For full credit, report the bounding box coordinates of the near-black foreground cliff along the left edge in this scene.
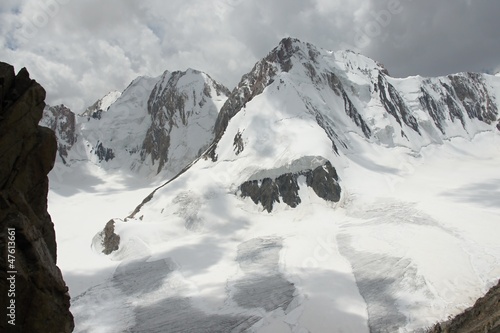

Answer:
[0,63,74,332]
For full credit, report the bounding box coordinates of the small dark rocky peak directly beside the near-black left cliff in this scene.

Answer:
[40,105,77,164]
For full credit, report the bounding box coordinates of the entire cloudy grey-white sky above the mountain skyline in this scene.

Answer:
[0,0,500,113]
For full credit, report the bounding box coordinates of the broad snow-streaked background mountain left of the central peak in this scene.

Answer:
[74,69,229,178]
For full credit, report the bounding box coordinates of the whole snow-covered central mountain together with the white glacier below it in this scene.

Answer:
[49,39,500,332]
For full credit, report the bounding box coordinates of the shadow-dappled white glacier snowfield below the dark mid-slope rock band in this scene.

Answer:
[59,133,500,332]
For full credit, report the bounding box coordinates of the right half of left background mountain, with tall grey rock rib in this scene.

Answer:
[141,70,229,172]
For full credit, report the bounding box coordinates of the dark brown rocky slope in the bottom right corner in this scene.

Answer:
[428,281,500,333]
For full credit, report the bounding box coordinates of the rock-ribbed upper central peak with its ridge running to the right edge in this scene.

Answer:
[208,38,498,159]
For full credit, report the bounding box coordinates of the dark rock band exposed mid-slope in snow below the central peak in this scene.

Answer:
[240,161,341,213]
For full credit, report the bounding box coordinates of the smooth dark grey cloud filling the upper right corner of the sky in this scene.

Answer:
[366,0,500,76]
